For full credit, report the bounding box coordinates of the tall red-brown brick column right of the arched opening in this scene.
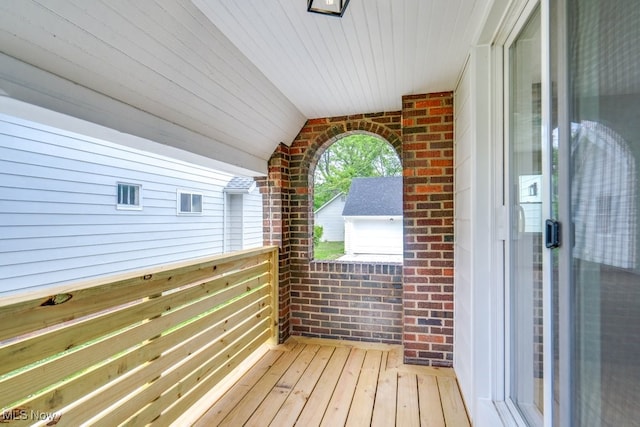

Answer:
[402,92,453,366]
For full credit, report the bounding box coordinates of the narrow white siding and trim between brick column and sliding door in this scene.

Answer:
[453,46,504,426]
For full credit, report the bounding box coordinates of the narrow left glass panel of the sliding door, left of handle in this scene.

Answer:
[508,4,548,425]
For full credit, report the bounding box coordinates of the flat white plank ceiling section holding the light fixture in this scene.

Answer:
[193,0,488,118]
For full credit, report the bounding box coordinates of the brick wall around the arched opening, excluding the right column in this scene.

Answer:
[290,112,402,343]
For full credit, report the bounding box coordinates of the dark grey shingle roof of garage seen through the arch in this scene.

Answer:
[342,176,402,216]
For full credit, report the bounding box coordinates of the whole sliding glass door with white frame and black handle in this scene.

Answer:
[504,0,640,427]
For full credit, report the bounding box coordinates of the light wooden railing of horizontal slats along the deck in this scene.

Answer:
[0,247,278,426]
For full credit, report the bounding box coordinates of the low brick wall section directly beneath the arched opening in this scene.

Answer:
[291,261,402,344]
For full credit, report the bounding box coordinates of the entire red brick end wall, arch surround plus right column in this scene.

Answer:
[260,93,453,366]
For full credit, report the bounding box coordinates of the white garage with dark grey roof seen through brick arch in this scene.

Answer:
[342,176,403,255]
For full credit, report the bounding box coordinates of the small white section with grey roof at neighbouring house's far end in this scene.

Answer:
[224,177,262,252]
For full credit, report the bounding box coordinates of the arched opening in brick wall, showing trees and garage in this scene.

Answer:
[313,132,403,262]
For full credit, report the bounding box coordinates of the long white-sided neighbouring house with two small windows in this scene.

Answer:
[0,114,262,294]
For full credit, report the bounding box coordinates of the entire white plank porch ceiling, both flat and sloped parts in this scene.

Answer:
[0,0,491,172]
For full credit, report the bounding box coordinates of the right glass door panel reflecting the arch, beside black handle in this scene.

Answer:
[560,0,640,427]
